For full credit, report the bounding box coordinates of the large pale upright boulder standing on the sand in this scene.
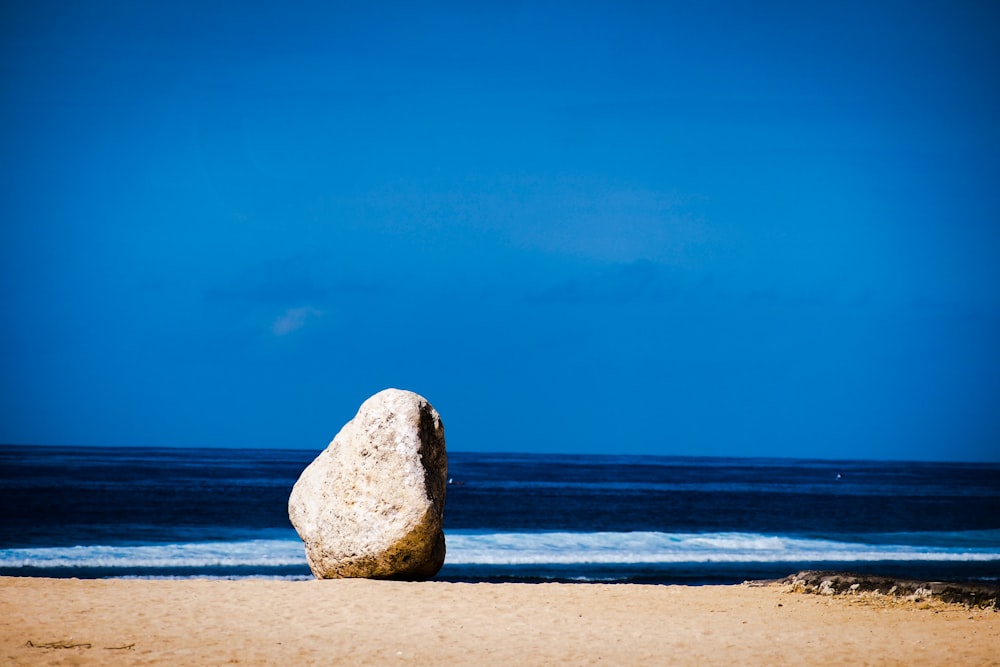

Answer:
[288,389,448,579]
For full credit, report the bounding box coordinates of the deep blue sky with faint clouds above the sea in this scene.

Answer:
[0,1,1000,461]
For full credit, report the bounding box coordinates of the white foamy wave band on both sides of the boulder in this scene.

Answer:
[0,531,1000,570]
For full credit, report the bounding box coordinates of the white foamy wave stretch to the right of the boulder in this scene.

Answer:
[447,532,1000,565]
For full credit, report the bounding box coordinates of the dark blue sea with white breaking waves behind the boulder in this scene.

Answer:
[0,446,1000,584]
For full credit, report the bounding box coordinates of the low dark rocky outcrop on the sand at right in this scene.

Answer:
[754,570,1000,610]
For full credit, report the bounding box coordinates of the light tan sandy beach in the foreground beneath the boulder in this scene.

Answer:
[0,578,1000,667]
